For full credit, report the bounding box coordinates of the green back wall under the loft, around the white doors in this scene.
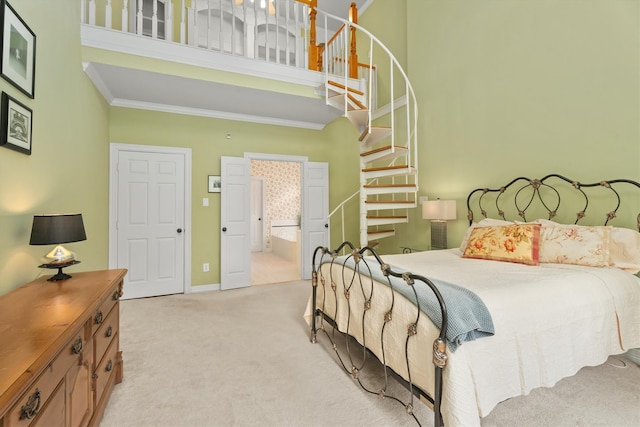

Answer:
[109,108,358,286]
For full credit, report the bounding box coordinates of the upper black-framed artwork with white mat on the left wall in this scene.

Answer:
[0,0,36,98]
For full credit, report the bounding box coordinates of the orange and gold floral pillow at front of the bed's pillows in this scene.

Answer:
[462,224,541,265]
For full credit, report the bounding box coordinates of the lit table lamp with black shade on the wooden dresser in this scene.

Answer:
[29,214,87,281]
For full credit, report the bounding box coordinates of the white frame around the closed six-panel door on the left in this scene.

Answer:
[109,142,191,293]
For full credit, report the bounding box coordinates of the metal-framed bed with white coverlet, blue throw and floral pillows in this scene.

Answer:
[306,174,640,426]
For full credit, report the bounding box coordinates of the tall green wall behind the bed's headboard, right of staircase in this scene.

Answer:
[396,0,640,251]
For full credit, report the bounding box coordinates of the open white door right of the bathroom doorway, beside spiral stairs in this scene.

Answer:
[301,162,329,280]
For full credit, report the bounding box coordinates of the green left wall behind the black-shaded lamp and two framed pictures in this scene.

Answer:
[0,0,109,294]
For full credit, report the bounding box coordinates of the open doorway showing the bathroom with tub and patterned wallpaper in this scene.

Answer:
[251,159,302,285]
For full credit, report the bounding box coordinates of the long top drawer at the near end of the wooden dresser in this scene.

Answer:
[3,330,86,427]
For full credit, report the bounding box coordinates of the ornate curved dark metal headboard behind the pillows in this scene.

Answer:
[467,174,640,230]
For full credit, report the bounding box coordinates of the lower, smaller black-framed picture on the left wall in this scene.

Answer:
[0,92,33,155]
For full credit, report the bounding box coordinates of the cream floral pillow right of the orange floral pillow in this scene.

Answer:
[538,220,612,267]
